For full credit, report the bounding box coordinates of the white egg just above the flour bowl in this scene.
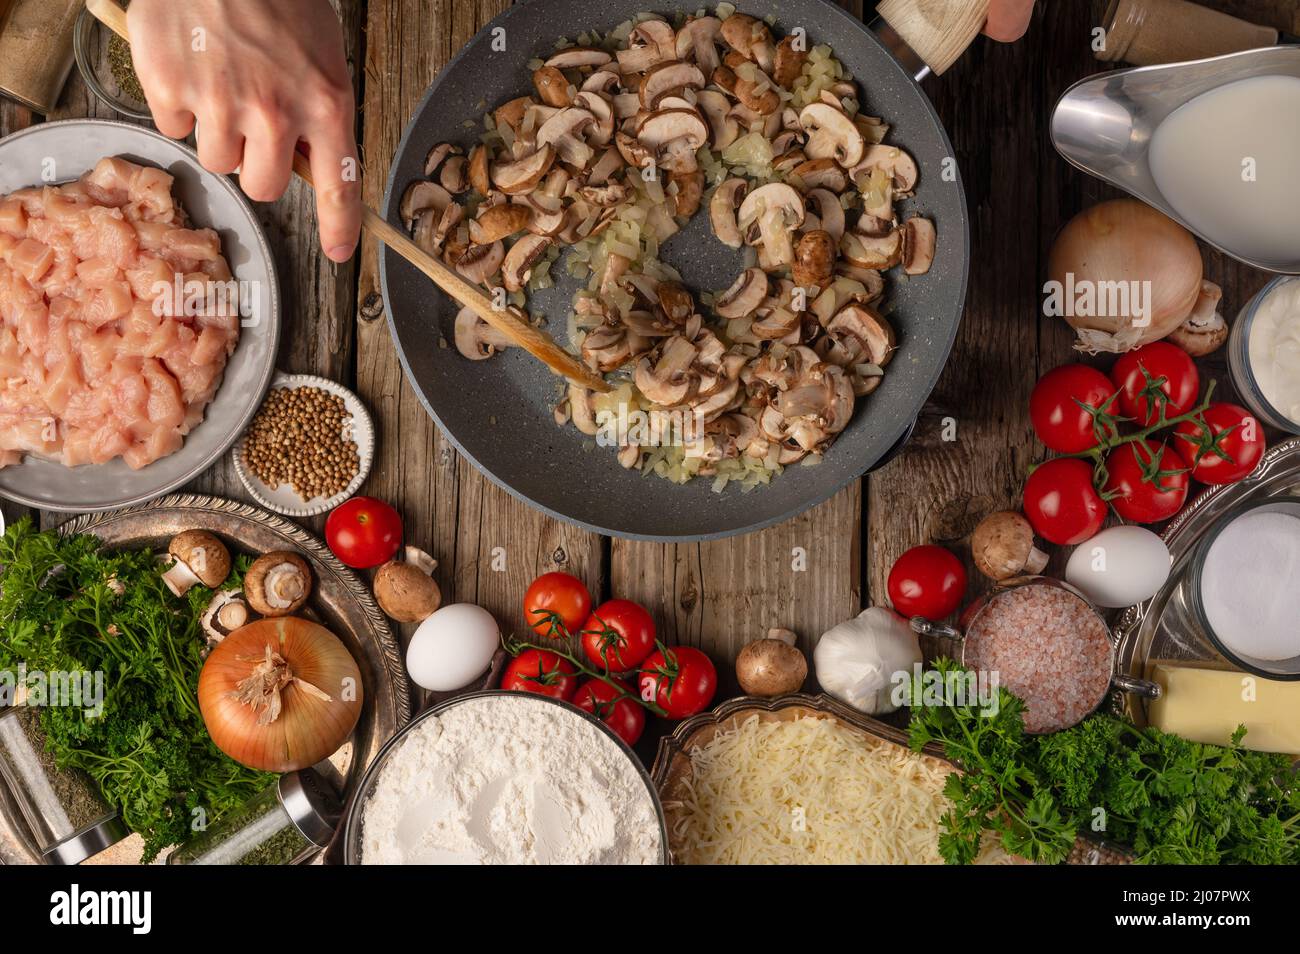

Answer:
[407,603,501,693]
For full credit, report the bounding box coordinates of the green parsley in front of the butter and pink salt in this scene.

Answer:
[909,659,1300,864]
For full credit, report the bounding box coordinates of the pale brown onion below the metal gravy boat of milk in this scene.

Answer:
[1044,199,1213,352]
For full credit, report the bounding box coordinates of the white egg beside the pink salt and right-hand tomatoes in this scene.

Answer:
[1065,526,1170,610]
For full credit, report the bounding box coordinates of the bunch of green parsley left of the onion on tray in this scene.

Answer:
[0,520,272,860]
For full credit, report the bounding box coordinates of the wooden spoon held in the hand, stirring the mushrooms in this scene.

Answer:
[86,0,610,393]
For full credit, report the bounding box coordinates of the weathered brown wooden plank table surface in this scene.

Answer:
[0,0,1295,738]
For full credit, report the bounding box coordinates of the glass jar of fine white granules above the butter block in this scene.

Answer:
[1187,496,1300,680]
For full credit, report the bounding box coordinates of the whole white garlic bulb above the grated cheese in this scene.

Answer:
[813,606,920,715]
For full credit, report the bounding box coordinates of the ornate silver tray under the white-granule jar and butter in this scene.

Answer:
[1114,438,1300,725]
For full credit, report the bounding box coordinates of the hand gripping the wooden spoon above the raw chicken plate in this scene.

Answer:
[127,0,361,261]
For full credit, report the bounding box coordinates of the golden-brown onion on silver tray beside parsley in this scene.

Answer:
[199,616,361,772]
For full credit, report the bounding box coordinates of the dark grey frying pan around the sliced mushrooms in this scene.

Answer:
[380,0,985,541]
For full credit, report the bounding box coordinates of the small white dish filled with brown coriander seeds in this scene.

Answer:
[235,373,374,517]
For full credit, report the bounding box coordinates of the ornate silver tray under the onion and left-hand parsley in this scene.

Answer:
[0,494,411,864]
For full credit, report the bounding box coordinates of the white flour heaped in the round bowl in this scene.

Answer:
[361,695,662,864]
